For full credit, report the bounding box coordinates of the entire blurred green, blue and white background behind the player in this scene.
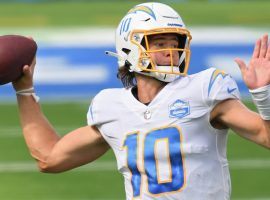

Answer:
[0,0,270,200]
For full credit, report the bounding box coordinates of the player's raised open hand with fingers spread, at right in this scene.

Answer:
[235,34,270,89]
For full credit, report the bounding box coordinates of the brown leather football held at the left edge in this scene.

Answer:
[0,35,37,85]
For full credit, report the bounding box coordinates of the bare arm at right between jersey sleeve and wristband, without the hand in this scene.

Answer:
[210,99,270,148]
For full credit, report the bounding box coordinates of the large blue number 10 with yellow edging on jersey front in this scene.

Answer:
[123,127,185,197]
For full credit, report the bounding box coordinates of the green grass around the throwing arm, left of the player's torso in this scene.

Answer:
[0,103,124,200]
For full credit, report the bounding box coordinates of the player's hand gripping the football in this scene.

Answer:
[12,58,36,91]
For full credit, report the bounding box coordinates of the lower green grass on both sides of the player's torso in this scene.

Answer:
[0,102,270,200]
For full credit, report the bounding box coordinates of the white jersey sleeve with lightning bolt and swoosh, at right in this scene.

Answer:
[203,68,240,107]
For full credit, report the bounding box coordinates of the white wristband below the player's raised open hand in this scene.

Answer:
[249,85,270,120]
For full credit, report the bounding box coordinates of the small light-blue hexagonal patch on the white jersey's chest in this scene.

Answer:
[169,99,190,118]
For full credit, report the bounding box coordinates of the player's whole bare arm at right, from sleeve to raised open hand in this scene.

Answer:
[211,34,270,148]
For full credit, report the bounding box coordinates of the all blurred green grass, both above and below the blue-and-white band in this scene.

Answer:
[0,0,270,200]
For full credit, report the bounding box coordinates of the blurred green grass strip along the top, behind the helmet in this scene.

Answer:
[0,0,270,28]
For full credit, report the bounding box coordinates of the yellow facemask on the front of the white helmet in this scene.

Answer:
[130,28,191,82]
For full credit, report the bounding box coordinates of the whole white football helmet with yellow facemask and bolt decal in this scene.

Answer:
[107,3,191,82]
